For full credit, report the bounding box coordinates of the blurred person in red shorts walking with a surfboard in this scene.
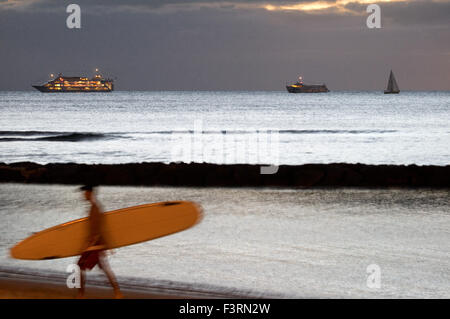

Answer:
[78,185,123,298]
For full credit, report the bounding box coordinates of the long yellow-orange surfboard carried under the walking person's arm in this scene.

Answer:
[10,201,202,260]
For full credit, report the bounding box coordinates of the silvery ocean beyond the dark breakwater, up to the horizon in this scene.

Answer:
[0,92,450,165]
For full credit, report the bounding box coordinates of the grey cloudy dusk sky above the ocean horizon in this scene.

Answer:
[0,0,450,91]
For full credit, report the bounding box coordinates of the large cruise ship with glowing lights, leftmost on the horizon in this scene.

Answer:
[32,69,114,93]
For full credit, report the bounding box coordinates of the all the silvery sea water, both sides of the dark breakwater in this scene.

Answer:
[0,92,450,298]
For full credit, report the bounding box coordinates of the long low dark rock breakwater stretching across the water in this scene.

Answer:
[0,162,450,189]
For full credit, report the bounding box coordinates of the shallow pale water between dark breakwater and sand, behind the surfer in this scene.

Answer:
[0,183,450,298]
